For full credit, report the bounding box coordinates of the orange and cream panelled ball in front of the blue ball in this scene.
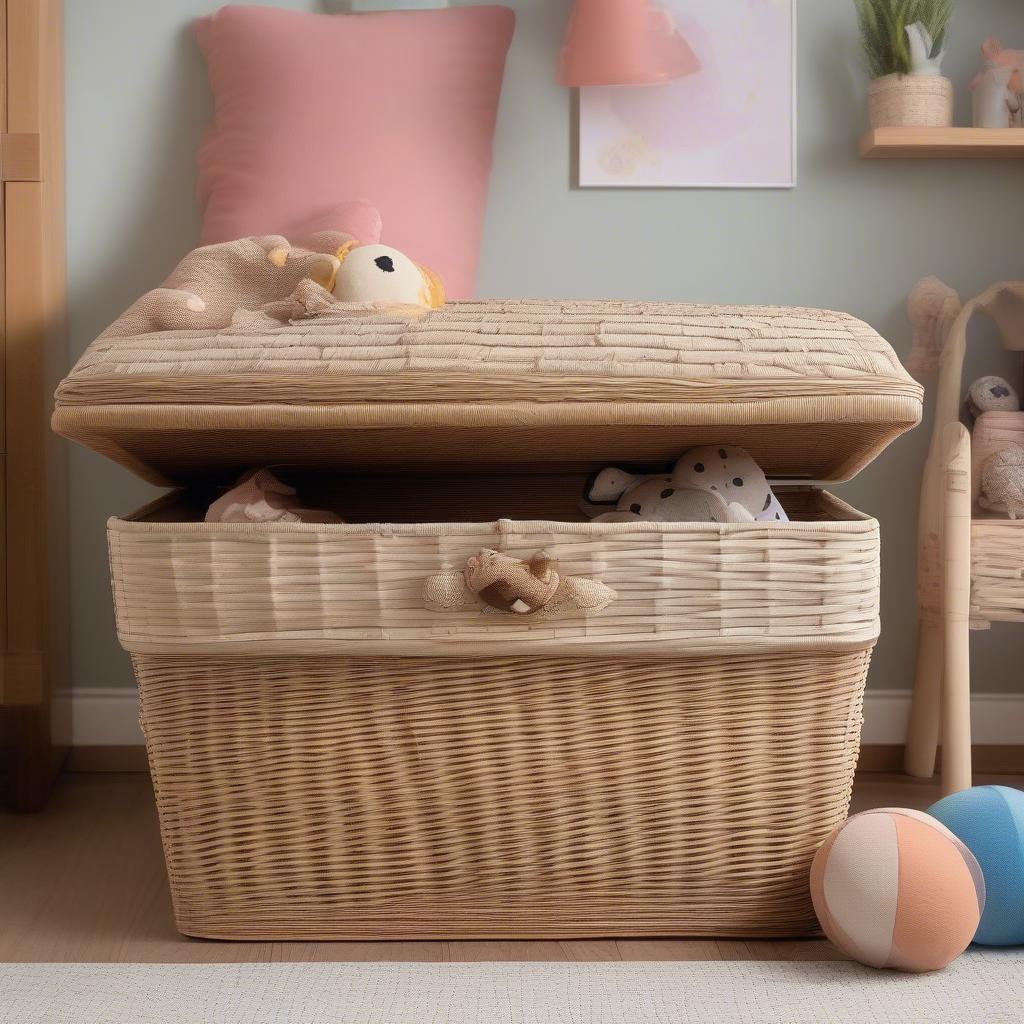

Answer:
[811,808,985,972]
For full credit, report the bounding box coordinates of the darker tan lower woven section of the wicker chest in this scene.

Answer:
[134,650,868,939]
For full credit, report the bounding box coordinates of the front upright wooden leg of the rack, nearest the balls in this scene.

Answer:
[941,423,971,796]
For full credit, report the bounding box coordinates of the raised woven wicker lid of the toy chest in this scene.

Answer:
[53,300,922,483]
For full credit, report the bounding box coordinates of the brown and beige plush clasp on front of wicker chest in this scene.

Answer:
[423,549,616,620]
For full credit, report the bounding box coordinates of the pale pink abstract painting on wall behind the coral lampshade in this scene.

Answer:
[580,0,797,188]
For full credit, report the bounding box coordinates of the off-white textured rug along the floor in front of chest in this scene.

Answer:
[0,951,1024,1024]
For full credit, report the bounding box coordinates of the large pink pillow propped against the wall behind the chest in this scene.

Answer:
[196,6,515,298]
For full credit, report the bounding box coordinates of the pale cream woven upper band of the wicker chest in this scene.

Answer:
[109,496,879,657]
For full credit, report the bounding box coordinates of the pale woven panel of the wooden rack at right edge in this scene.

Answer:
[971,519,1024,629]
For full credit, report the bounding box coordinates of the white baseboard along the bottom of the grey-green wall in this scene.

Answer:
[66,687,1024,746]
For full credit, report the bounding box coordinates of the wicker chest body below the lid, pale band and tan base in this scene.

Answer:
[110,490,879,939]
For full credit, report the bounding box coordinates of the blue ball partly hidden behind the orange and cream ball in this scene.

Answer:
[928,785,1024,946]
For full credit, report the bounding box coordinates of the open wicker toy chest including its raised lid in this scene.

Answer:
[54,301,922,939]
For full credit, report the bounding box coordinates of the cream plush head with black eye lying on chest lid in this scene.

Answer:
[312,243,444,309]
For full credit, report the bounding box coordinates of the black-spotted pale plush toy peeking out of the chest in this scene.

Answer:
[587,444,790,522]
